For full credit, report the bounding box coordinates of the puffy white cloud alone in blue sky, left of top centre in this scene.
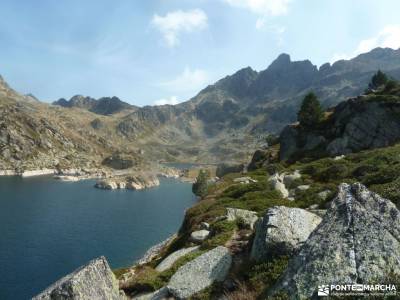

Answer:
[151,9,208,48]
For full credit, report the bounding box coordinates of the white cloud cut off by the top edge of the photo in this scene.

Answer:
[223,0,291,16]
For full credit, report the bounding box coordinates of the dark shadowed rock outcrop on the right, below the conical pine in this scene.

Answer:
[280,82,400,160]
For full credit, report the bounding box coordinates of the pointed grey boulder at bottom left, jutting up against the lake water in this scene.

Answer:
[33,257,122,300]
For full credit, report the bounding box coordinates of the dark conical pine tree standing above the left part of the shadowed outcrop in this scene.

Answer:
[297,92,323,128]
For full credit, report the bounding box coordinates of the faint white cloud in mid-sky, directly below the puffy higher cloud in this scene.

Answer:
[159,67,210,92]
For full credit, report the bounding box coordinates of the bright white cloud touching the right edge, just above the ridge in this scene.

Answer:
[331,25,400,62]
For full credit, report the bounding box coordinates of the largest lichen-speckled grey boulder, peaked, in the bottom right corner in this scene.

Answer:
[271,183,400,299]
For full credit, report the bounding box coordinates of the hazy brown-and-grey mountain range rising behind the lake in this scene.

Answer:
[0,48,400,169]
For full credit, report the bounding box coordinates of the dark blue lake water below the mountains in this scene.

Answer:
[0,177,195,300]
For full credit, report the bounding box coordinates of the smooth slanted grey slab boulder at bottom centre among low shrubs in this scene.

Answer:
[168,246,232,299]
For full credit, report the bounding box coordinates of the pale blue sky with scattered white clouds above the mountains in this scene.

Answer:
[0,0,400,106]
